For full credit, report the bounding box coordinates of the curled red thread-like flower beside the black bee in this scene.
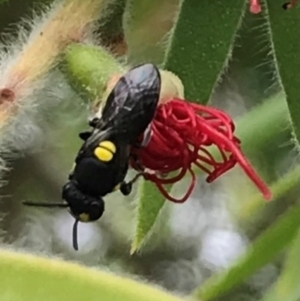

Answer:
[131,99,271,203]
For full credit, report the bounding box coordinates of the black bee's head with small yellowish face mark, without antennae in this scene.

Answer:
[62,181,104,222]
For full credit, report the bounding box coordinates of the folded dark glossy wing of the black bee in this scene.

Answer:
[97,64,161,141]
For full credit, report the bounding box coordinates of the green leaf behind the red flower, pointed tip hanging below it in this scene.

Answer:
[131,0,246,252]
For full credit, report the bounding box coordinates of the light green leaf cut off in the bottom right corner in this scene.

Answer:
[261,229,300,301]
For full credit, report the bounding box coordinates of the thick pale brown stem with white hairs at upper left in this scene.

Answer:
[0,0,106,152]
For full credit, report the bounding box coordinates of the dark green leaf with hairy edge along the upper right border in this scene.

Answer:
[264,0,300,151]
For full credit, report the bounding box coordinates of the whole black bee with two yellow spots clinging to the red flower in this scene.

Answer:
[23,64,161,250]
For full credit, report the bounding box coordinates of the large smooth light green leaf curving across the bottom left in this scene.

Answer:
[0,250,185,301]
